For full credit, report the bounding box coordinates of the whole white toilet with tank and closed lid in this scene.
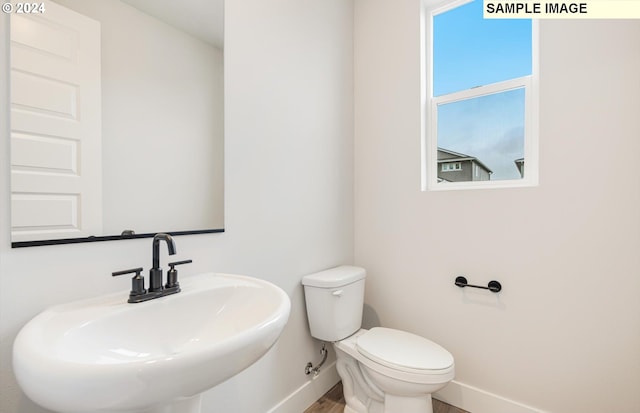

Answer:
[302,266,454,413]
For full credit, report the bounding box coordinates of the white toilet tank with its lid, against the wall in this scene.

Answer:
[302,265,366,342]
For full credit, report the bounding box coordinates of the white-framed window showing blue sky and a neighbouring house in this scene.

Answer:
[423,0,538,190]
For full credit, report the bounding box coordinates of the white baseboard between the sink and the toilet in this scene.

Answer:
[267,361,340,413]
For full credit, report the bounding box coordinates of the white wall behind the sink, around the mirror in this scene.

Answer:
[0,0,353,413]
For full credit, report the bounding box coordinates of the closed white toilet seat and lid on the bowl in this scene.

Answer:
[356,327,454,375]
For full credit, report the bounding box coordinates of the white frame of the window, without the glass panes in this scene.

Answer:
[420,0,539,191]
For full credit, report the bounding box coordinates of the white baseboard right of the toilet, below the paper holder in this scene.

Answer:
[433,380,546,413]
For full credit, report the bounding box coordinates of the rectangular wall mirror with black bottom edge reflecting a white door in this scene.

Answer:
[10,0,224,247]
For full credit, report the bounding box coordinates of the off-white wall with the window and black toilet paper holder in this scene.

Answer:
[354,0,640,413]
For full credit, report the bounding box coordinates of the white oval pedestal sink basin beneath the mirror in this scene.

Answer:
[13,273,291,413]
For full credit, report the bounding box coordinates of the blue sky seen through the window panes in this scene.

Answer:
[433,0,531,180]
